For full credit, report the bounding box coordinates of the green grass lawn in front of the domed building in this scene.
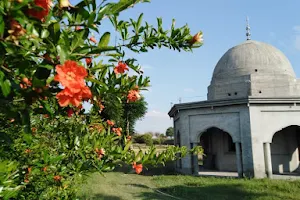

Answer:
[80,172,300,200]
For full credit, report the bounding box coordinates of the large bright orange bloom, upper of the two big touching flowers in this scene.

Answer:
[54,60,88,93]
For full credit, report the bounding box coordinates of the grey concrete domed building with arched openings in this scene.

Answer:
[169,38,300,178]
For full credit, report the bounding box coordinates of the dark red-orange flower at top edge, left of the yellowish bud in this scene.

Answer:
[28,0,52,21]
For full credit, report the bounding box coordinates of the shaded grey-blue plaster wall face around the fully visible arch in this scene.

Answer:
[174,105,253,176]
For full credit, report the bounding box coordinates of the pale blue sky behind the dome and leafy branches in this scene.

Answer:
[71,0,300,133]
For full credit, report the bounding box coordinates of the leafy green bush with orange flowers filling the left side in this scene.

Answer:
[0,0,202,199]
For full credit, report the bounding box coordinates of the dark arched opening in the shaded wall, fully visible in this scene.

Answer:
[198,127,237,172]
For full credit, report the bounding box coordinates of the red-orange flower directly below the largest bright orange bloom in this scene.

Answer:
[56,86,92,107]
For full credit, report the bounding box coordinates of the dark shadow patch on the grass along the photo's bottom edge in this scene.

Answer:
[136,183,281,200]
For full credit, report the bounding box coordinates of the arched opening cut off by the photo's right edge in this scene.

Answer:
[271,125,300,175]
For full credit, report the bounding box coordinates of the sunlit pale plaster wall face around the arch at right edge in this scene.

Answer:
[249,104,300,178]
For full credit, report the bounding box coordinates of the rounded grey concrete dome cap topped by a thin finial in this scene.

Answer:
[212,40,296,81]
